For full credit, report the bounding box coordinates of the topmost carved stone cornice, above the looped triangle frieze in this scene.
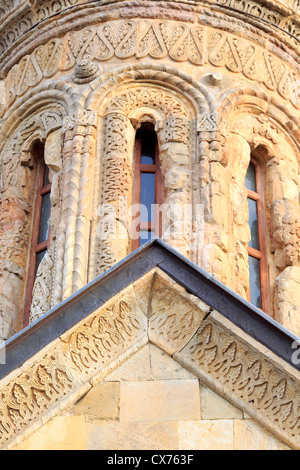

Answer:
[0,0,300,68]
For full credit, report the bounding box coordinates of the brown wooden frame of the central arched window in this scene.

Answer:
[132,124,163,251]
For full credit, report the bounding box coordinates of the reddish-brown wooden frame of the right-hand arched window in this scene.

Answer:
[247,155,270,314]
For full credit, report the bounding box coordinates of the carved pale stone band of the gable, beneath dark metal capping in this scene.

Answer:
[0,268,300,449]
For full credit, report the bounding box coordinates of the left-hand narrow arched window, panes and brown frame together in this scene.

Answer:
[23,142,51,326]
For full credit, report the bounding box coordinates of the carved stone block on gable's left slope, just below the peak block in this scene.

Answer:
[62,287,147,380]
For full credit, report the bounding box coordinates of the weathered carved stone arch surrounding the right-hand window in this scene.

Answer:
[218,88,300,316]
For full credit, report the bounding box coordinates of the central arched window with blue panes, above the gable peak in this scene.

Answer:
[132,124,163,250]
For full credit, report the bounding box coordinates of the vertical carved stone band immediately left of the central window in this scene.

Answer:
[94,113,133,275]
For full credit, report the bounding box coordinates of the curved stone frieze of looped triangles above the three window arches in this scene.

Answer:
[5,20,300,115]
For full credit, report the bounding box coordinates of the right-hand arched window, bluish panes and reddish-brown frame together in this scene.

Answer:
[246,157,269,313]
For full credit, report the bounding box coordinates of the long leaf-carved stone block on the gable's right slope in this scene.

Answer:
[183,320,300,439]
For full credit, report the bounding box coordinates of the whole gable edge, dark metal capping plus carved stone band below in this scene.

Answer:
[0,239,300,448]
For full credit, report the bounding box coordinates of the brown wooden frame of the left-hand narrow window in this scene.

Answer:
[23,143,51,328]
